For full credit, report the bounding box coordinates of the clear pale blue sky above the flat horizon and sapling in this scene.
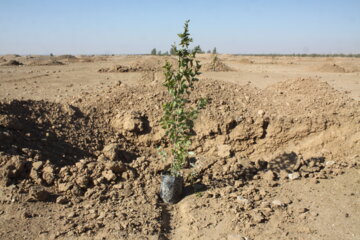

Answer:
[0,0,360,54]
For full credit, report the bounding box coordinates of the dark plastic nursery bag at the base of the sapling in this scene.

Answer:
[160,175,183,203]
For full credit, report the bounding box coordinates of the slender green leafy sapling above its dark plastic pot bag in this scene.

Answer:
[161,20,207,202]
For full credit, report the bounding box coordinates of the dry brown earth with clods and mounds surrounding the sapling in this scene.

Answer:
[0,54,360,240]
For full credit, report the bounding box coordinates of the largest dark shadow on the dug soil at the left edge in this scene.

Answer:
[0,101,91,167]
